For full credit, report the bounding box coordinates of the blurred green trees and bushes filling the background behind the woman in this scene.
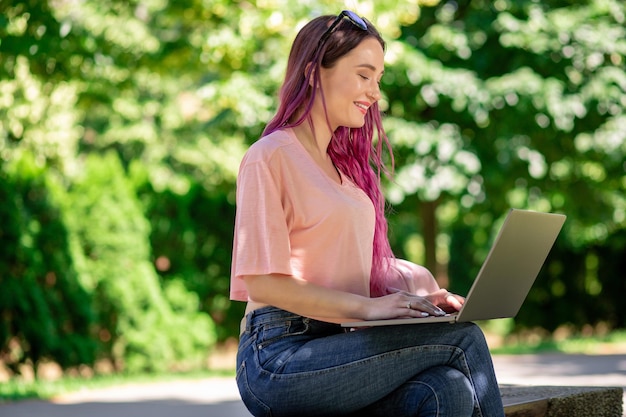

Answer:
[0,0,626,376]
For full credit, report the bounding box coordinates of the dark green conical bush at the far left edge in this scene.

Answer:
[0,153,97,373]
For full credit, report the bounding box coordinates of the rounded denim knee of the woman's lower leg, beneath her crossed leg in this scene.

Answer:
[354,366,474,417]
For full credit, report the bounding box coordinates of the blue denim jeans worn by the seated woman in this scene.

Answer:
[237,307,504,417]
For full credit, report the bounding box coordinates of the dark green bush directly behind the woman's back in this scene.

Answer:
[130,162,245,341]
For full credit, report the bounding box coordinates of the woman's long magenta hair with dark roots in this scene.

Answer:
[263,16,393,296]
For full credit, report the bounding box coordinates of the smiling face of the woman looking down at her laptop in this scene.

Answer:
[313,37,384,131]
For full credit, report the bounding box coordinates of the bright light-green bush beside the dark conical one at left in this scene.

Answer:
[58,152,215,372]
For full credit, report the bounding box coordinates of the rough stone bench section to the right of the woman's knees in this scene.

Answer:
[500,385,624,417]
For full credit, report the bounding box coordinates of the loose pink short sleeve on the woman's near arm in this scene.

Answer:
[231,154,291,301]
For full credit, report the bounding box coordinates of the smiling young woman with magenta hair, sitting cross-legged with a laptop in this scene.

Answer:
[231,11,504,417]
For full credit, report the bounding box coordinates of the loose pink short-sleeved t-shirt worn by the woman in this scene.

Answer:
[230,129,375,301]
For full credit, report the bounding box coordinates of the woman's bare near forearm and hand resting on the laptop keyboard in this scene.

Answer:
[243,275,443,320]
